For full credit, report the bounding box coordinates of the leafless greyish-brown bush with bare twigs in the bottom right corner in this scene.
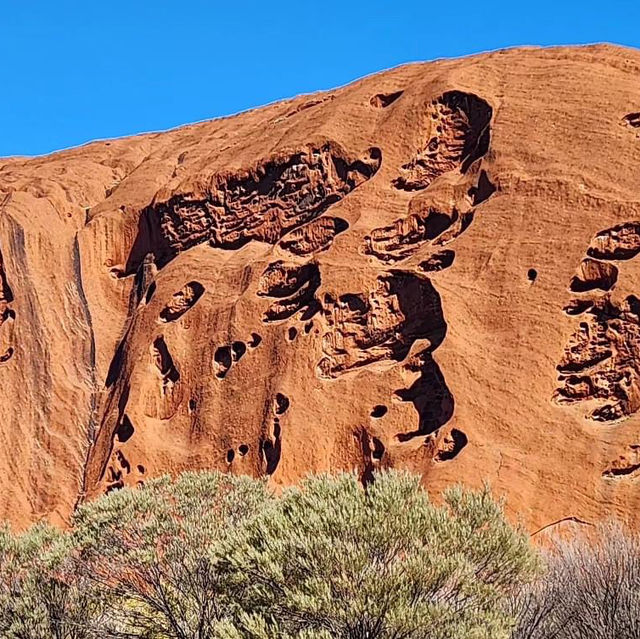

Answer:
[510,523,640,639]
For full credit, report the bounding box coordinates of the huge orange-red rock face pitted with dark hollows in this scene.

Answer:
[0,46,640,532]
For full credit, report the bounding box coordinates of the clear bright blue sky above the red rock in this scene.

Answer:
[0,0,640,156]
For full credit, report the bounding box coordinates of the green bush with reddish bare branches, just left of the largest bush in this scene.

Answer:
[72,473,268,639]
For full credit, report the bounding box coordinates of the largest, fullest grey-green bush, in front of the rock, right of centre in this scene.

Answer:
[226,472,537,639]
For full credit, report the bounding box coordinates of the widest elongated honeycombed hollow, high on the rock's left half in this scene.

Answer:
[139,141,382,272]
